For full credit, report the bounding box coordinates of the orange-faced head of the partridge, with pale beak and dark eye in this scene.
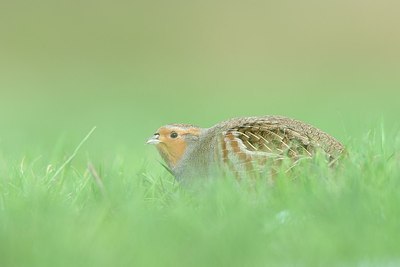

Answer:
[147,124,201,169]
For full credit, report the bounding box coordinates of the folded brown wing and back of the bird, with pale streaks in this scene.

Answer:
[218,116,343,176]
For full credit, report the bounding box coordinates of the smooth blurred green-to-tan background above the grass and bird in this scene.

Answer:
[0,0,400,157]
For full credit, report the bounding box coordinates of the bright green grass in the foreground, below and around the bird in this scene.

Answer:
[0,123,400,266]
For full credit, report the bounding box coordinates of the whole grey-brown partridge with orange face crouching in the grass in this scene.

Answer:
[147,115,345,181]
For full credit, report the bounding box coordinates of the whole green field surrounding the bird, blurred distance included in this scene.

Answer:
[0,0,400,267]
